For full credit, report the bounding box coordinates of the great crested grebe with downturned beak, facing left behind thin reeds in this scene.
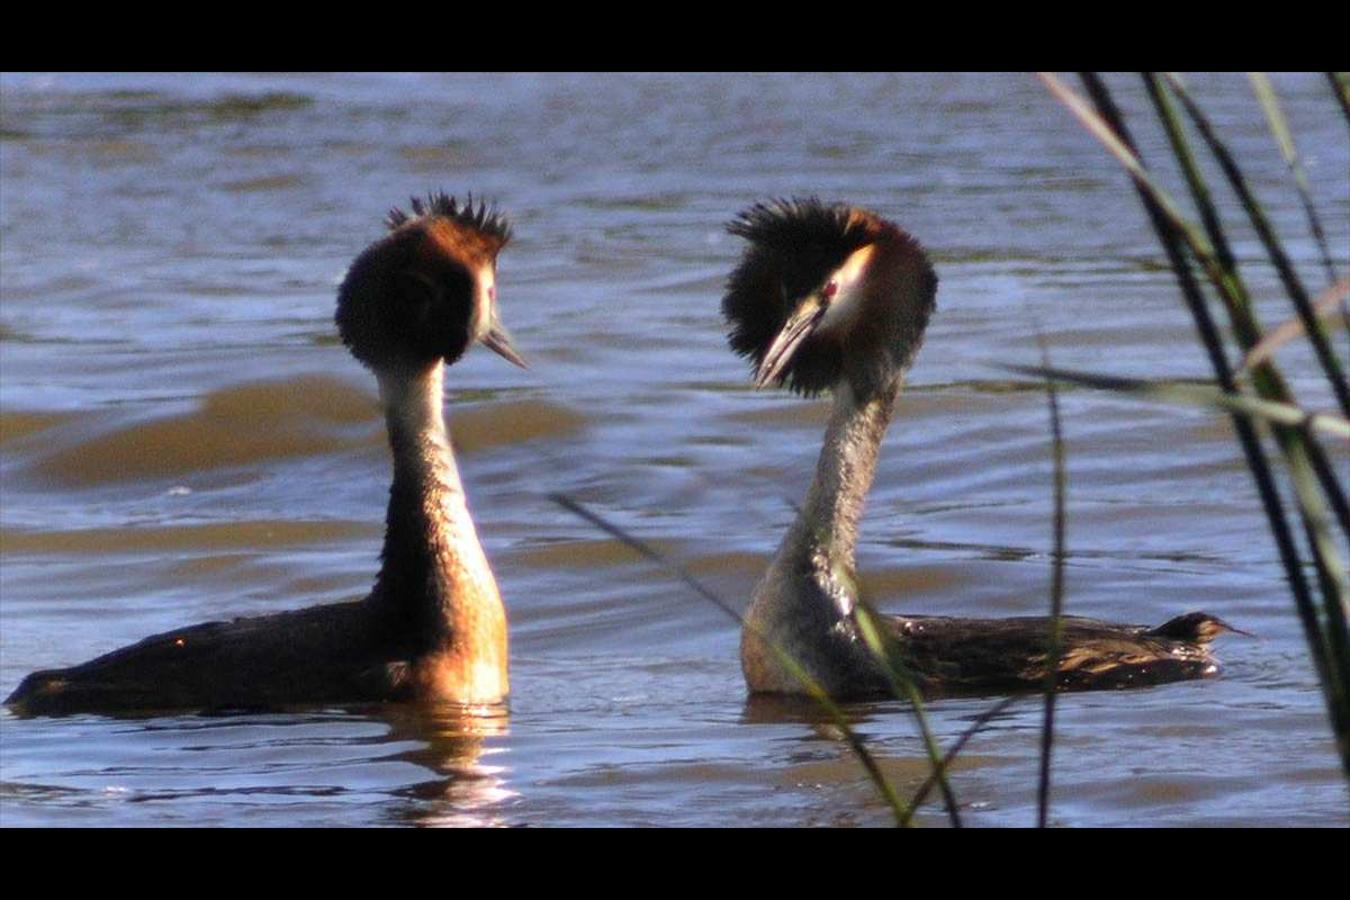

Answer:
[722,197,1237,698]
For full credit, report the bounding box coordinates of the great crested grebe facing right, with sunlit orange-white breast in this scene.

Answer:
[5,194,524,715]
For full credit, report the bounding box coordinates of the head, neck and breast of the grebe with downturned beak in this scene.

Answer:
[722,197,937,694]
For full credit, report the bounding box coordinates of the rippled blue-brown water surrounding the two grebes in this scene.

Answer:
[0,74,1350,826]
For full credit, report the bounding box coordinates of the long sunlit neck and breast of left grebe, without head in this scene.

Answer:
[373,363,505,664]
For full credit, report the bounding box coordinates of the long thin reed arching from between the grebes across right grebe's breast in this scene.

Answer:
[548,494,923,827]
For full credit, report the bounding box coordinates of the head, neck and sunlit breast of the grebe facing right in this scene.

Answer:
[336,194,524,702]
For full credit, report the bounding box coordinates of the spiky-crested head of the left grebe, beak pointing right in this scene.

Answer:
[336,193,525,374]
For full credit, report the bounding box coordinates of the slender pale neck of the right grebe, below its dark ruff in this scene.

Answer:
[778,381,899,572]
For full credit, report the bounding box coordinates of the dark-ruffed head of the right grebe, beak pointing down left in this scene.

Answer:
[722,197,937,397]
